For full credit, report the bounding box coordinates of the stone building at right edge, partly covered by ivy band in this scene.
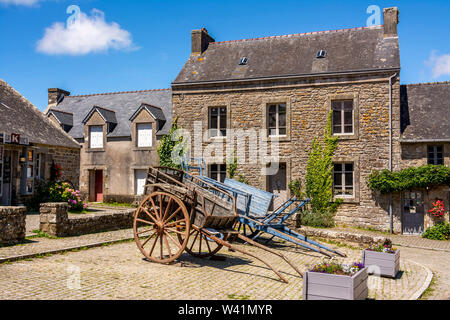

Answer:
[396,82,450,233]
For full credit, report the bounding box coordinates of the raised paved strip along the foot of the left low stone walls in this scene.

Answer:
[0,229,133,259]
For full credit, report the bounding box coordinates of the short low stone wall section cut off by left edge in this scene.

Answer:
[0,207,27,244]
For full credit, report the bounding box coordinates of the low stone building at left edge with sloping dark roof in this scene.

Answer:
[0,80,80,206]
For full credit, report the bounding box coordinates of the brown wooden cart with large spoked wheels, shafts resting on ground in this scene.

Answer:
[133,167,302,283]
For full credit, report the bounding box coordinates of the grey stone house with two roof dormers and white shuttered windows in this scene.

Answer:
[45,89,172,202]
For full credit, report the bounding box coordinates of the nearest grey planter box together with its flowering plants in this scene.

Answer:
[303,262,369,300]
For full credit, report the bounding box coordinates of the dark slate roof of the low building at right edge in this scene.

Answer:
[400,82,450,141]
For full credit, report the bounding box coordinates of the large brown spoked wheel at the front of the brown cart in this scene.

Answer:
[133,192,191,263]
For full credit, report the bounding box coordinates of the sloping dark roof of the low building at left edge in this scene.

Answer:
[0,79,80,148]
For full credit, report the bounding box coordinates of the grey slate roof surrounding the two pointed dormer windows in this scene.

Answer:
[52,89,172,139]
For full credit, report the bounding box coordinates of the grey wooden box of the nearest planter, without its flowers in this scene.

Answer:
[303,268,369,300]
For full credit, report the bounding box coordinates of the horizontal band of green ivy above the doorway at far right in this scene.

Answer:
[368,165,450,194]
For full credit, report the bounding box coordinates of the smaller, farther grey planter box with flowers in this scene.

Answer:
[362,239,400,278]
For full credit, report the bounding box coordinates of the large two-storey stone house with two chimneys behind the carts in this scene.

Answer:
[172,8,408,232]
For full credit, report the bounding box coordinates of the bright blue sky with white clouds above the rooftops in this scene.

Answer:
[0,0,450,110]
